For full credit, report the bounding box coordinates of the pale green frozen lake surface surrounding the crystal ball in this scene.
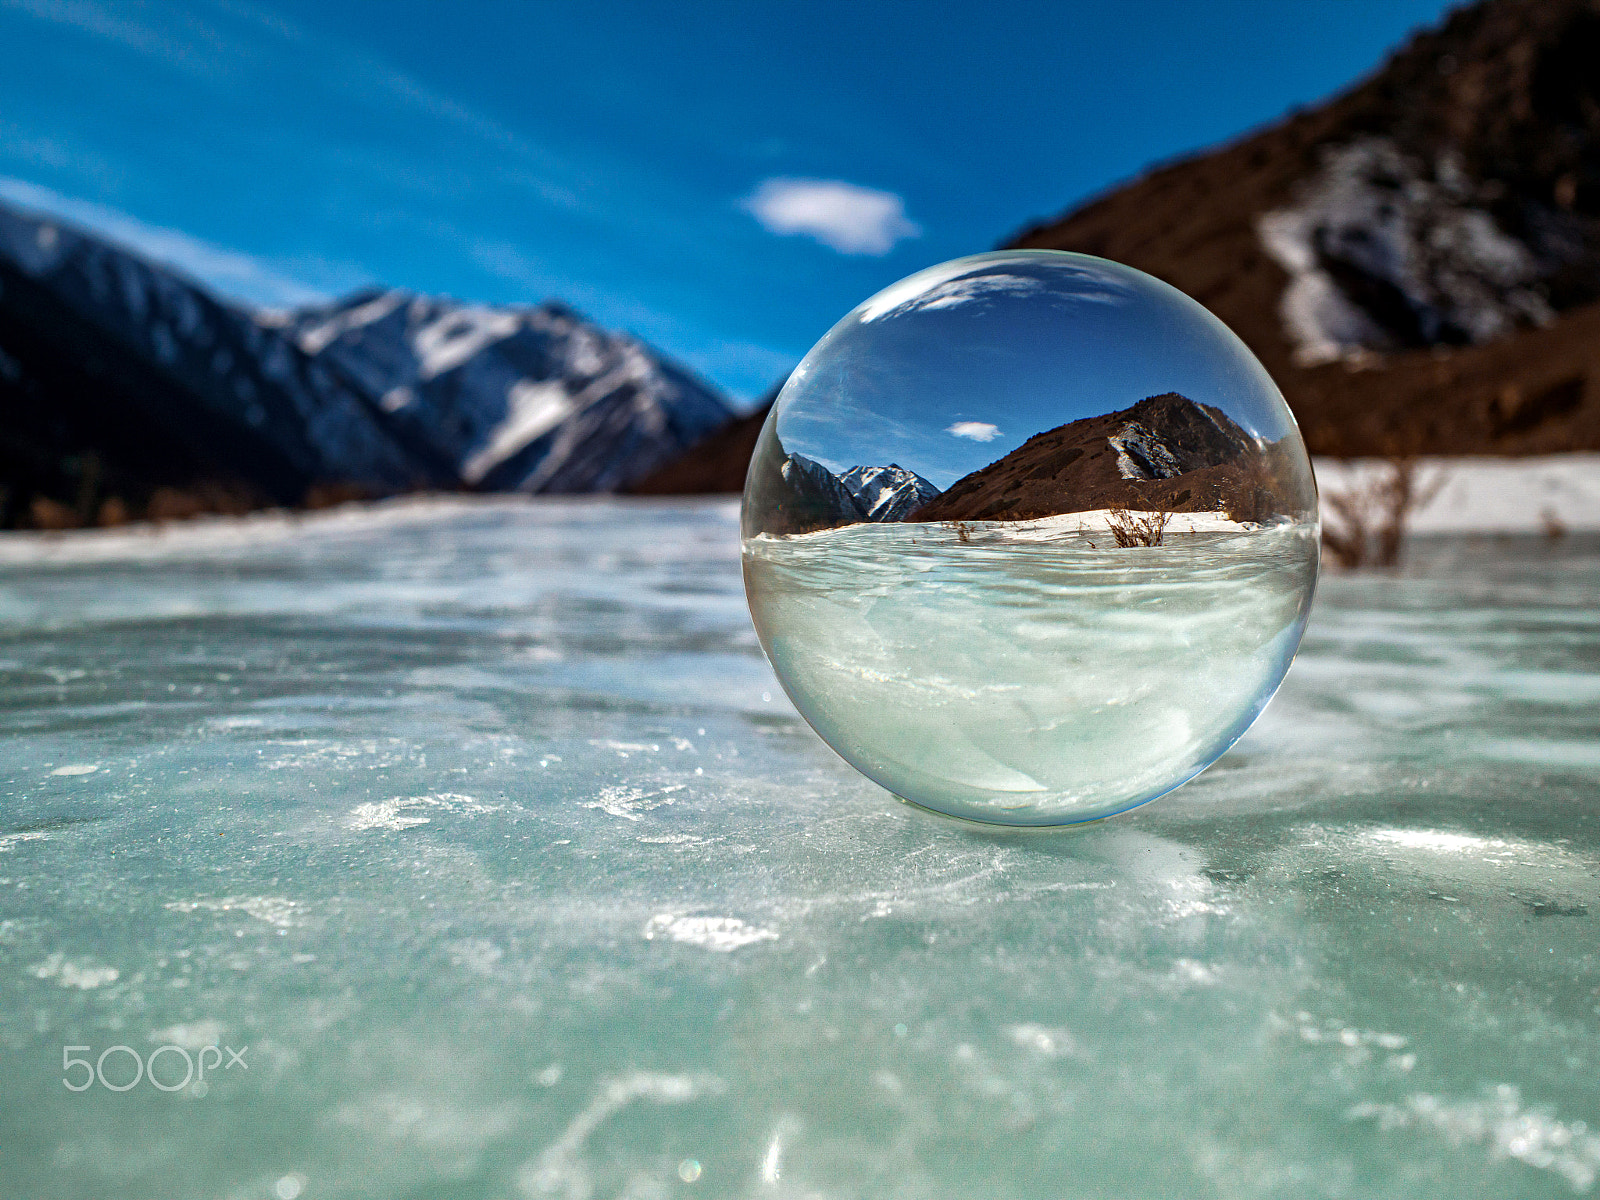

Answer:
[0,501,1600,1200]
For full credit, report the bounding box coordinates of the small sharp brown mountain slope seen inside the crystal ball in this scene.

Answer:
[906,392,1285,522]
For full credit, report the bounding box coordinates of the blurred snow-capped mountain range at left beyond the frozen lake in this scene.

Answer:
[0,196,731,523]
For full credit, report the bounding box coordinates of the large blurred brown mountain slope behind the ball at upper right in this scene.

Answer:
[1011,0,1600,454]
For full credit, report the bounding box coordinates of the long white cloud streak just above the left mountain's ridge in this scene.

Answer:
[0,176,328,307]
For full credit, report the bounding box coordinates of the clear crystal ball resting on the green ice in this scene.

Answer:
[741,250,1318,826]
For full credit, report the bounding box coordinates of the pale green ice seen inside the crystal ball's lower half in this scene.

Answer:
[744,514,1317,826]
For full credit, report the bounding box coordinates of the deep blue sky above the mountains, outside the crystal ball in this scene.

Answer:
[0,0,1448,406]
